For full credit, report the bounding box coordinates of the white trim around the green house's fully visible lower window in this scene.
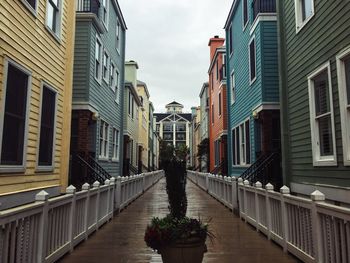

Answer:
[307,62,337,166]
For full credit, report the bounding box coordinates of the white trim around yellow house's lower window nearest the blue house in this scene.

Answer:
[36,81,58,172]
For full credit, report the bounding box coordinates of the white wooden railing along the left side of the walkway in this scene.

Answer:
[0,171,164,263]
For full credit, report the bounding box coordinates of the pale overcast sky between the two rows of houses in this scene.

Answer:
[119,0,232,112]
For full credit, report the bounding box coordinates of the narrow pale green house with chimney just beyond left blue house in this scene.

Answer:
[123,61,141,176]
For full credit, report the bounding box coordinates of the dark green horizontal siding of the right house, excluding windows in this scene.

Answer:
[280,1,350,187]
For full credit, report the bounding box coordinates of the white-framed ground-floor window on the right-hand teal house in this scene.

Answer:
[232,120,251,165]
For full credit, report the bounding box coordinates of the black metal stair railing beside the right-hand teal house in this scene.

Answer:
[240,152,282,189]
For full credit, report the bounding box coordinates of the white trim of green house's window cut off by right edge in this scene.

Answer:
[336,46,350,166]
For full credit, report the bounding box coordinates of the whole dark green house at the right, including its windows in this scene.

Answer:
[278,0,350,203]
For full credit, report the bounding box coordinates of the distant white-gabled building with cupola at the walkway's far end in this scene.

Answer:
[154,101,191,164]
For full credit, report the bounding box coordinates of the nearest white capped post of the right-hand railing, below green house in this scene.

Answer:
[311,190,326,262]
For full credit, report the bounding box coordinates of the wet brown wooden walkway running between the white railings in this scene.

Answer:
[59,179,299,263]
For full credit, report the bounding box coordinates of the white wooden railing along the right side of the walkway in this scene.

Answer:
[187,171,350,263]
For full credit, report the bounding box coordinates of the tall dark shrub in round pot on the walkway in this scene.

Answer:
[145,143,213,263]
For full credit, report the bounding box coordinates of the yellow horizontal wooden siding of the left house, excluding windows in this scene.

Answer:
[0,0,75,193]
